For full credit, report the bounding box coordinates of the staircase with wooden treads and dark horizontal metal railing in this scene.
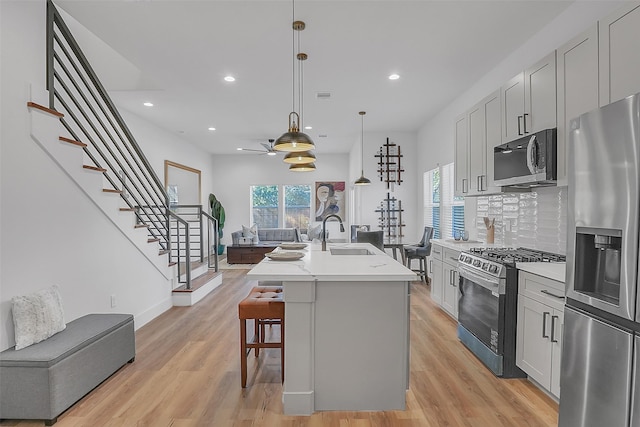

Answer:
[27,0,222,305]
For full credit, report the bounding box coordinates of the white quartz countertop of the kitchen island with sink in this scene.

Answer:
[247,243,418,282]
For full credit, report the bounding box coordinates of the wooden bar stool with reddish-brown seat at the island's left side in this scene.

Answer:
[238,286,284,388]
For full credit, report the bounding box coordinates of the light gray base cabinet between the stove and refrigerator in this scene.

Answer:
[516,271,564,398]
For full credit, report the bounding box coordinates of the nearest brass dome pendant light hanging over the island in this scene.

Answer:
[273,1,315,152]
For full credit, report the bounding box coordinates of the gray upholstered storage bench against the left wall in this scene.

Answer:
[0,314,135,425]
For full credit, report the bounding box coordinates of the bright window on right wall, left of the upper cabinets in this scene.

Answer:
[424,163,464,239]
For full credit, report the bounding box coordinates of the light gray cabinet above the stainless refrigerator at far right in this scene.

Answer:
[599,3,640,106]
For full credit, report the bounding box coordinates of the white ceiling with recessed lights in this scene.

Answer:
[55,0,571,155]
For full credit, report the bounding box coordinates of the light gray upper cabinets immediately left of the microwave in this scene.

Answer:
[455,90,501,196]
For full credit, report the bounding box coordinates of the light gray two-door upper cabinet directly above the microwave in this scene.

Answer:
[501,51,556,142]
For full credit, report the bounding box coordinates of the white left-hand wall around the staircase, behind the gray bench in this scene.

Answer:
[0,0,218,350]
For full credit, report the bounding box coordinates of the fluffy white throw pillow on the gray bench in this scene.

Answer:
[11,285,66,350]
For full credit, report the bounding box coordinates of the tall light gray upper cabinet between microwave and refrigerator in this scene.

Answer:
[557,24,599,185]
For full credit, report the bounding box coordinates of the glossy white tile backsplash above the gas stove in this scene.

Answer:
[465,187,567,254]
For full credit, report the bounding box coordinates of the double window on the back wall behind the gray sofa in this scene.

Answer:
[251,185,311,229]
